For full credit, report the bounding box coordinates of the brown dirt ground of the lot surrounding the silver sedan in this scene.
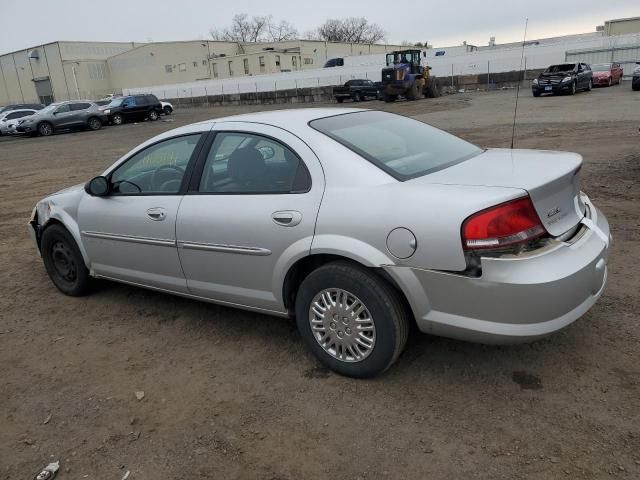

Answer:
[0,85,640,480]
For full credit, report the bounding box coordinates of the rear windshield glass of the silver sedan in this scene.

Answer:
[309,111,482,180]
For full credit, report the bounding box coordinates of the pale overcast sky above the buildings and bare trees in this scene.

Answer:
[0,0,640,54]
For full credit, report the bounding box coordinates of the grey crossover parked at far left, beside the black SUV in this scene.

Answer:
[16,100,107,137]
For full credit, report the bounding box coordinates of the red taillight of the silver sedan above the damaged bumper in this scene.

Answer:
[462,197,547,250]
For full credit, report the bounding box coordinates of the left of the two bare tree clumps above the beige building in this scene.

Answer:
[209,13,298,42]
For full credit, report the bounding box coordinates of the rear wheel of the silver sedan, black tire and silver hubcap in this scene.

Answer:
[295,262,409,378]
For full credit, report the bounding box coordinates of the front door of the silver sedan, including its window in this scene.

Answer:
[78,133,203,293]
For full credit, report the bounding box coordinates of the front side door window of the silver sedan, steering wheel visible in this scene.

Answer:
[110,133,202,195]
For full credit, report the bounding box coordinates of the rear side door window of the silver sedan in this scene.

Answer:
[199,132,311,194]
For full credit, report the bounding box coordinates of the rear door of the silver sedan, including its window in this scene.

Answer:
[176,122,324,312]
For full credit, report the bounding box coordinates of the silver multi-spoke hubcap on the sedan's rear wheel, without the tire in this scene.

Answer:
[309,288,376,363]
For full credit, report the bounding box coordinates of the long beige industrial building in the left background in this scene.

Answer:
[0,40,399,105]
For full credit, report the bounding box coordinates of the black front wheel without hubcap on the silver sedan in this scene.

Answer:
[40,224,91,297]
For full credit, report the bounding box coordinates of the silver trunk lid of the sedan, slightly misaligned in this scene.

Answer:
[410,149,585,237]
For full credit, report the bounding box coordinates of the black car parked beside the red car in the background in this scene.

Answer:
[531,63,593,97]
